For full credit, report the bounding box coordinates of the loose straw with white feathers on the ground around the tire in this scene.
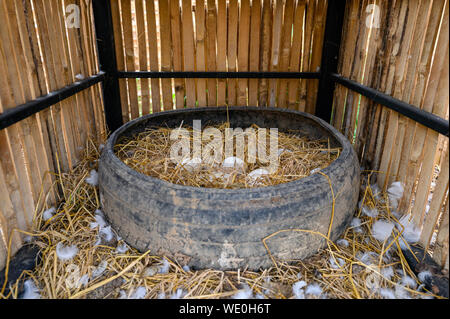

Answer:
[0,138,442,299]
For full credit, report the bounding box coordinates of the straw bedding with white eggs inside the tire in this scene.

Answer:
[115,123,341,188]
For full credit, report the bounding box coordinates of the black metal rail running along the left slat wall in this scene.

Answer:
[0,71,106,130]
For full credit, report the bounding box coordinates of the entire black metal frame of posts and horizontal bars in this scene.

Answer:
[0,0,449,137]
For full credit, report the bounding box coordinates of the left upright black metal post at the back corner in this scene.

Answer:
[92,0,123,132]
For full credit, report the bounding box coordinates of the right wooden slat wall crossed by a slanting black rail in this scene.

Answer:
[332,0,449,267]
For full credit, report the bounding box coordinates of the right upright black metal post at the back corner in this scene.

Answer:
[315,0,346,122]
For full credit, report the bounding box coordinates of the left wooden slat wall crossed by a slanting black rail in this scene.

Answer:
[0,0,105,269]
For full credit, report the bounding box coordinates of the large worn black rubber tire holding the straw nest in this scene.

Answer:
[99,107,360,270]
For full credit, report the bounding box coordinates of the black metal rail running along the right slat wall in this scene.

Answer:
[330,73,449,137]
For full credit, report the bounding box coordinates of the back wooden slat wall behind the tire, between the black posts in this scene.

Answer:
[111,0,327,117]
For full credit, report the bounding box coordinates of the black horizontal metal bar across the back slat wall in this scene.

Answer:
[117,71,320,79]
